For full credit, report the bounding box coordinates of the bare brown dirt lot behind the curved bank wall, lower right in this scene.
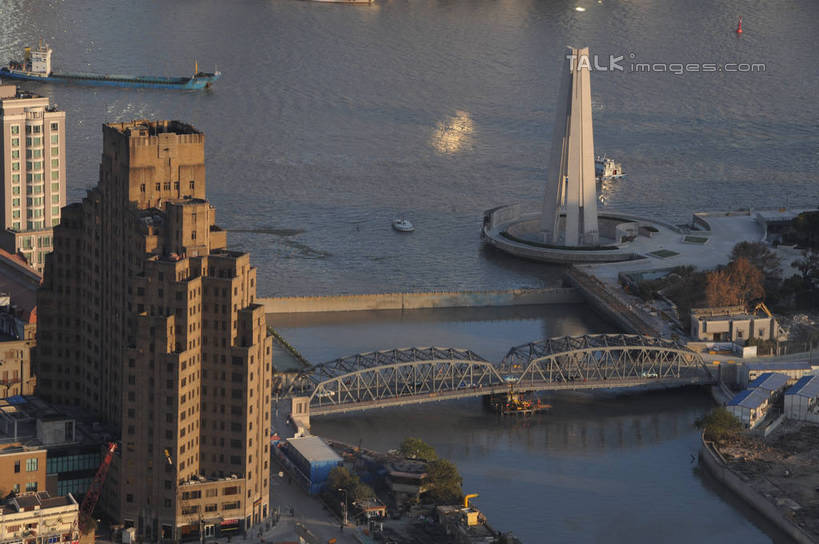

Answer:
[719,421,819,535]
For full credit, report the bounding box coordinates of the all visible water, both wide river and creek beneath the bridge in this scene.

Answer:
[0,0,819,542]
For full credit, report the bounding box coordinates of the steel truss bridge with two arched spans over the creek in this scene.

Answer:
[288,334,714,417]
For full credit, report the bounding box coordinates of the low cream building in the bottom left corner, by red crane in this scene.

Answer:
[0,491,80,544]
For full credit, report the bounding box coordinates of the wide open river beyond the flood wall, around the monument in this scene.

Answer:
[0,0,819,295]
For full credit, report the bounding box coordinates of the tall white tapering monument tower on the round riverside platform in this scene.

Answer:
[540,47,600,246]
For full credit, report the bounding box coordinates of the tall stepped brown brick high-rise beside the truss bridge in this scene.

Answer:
[35,121,272,540]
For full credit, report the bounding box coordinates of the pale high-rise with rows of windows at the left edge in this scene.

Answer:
[0,85,65,272]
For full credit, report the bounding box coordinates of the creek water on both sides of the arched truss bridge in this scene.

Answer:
[268,304,789,544]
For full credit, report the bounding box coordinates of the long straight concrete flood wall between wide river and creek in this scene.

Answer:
[256,287,585,314]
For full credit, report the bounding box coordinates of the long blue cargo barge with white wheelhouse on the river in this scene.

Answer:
[0,42,222,90]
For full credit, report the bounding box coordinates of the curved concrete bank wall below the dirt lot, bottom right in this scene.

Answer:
[700,437,819,544]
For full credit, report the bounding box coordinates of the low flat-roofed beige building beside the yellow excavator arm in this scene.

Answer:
[691,306,787,343]
